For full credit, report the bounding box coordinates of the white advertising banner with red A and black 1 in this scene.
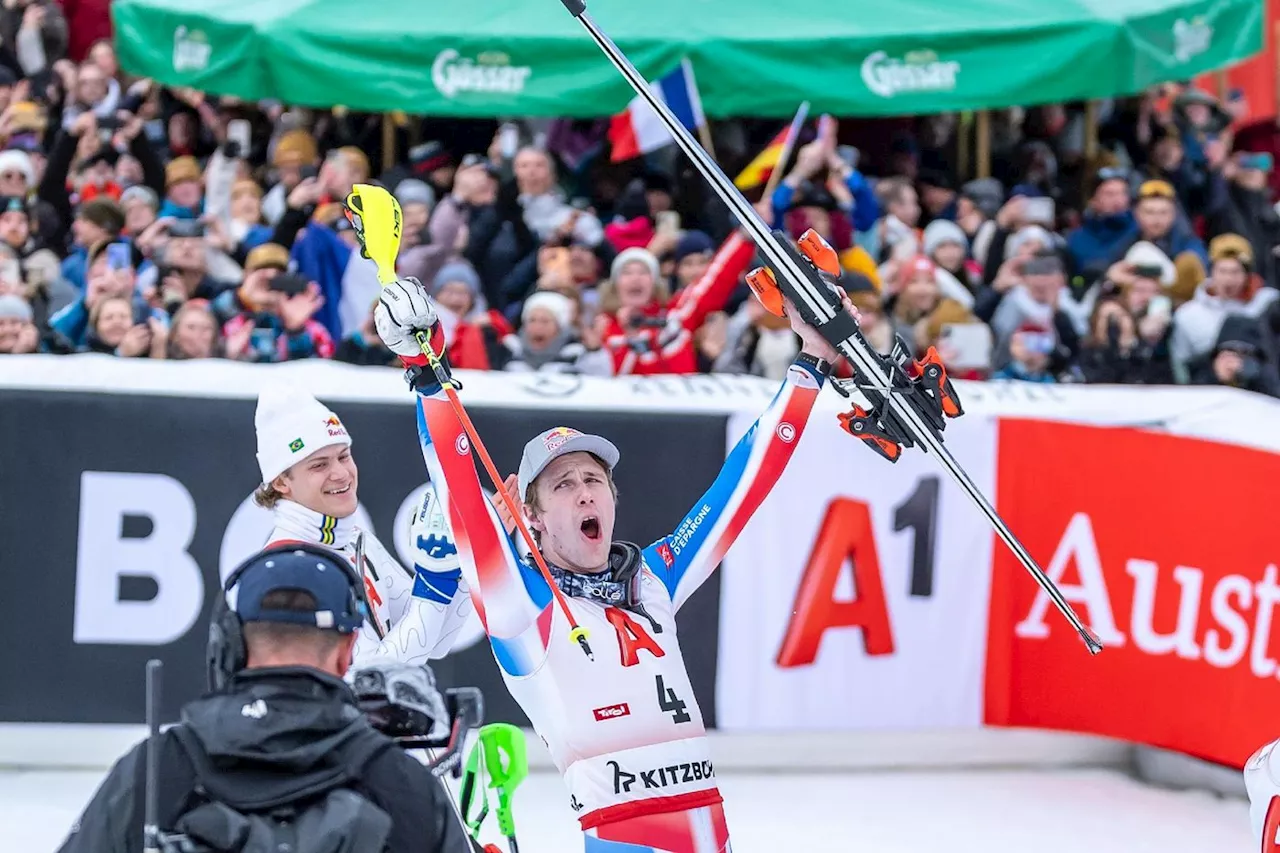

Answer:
[716,411,997,731]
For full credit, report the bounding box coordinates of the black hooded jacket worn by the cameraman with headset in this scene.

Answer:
[60,667,472,853]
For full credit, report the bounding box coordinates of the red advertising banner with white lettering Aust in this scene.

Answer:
[984,420,1280,767]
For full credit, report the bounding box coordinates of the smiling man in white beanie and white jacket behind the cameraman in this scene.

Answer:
[253,386,471,663]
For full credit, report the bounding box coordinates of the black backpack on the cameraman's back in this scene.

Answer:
[164,725,394,853]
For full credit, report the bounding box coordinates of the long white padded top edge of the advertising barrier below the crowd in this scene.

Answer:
[0,353,1280,455]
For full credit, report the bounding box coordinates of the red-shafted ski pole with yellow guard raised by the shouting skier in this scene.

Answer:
[343,183,595,661]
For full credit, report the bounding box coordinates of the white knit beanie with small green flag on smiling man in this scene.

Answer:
[253,386,351,483]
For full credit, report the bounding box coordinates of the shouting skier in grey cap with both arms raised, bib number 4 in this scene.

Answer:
[375,270,856,853]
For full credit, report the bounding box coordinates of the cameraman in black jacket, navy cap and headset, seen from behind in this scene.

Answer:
[60,544,472,853]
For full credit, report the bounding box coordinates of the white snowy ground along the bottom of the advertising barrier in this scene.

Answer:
[0,770,1256,853]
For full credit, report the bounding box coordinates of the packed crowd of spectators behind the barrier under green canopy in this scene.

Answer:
[0,9,1280,394]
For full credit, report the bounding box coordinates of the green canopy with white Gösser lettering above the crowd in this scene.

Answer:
[111,0,1265,118]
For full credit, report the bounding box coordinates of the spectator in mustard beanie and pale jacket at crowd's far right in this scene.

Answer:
[1169,234,1280,382]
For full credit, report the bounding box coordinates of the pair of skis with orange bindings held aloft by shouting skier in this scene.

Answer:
[561,0,1102,654]
